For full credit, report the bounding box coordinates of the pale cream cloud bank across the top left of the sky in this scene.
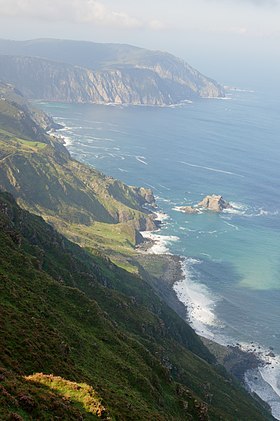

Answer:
[0,0,165,30]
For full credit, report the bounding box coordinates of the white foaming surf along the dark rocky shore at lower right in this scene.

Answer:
[173,258,280,420]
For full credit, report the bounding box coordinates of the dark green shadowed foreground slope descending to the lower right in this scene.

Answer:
[0,194,270,420]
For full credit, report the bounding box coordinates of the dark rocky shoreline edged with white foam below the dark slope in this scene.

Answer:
[139,212,279,419]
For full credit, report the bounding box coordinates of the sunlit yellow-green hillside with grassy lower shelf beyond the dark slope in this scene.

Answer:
[0,90,158,272]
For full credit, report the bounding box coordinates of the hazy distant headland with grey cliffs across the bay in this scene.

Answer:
[0,39,224,105]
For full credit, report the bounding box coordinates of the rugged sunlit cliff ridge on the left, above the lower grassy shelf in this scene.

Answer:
[0,84,155,230]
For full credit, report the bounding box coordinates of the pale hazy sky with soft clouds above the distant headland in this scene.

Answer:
[0,0,280,89]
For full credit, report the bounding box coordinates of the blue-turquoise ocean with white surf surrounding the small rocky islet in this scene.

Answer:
[40,89,280,419]
